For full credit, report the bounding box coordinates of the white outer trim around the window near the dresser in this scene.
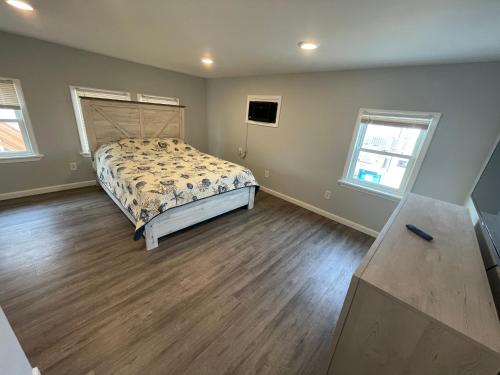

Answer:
[339,108,441,198]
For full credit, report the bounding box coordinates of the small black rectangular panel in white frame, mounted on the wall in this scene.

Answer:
[245,95,281,127]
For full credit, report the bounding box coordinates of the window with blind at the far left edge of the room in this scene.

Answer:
[0,78,42,162]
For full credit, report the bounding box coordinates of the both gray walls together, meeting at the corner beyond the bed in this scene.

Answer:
[0,32,500,235]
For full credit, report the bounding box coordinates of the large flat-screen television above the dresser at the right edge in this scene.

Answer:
[472,138,500,259]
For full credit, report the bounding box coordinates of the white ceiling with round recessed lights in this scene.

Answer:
[0,0,500,77]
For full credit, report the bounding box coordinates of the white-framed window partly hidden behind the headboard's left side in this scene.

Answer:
[70,86,131,156]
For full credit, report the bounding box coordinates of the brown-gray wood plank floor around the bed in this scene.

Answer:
[0,188,373,375]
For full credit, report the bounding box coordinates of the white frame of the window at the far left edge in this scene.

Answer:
[0,77,43,163]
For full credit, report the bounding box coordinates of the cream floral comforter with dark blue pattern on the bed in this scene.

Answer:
[95,138,258,238]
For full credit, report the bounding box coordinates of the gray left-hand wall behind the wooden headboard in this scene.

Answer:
[0,32,207,193]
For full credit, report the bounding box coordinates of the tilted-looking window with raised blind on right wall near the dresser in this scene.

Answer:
[340,109,440,197]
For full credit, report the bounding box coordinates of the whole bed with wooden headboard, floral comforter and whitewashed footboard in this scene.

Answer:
[81,98,258,250]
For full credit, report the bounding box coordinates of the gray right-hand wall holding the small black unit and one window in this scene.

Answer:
[207,63,500,230]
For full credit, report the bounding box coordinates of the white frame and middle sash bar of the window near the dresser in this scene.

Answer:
[339,108,441,200]
